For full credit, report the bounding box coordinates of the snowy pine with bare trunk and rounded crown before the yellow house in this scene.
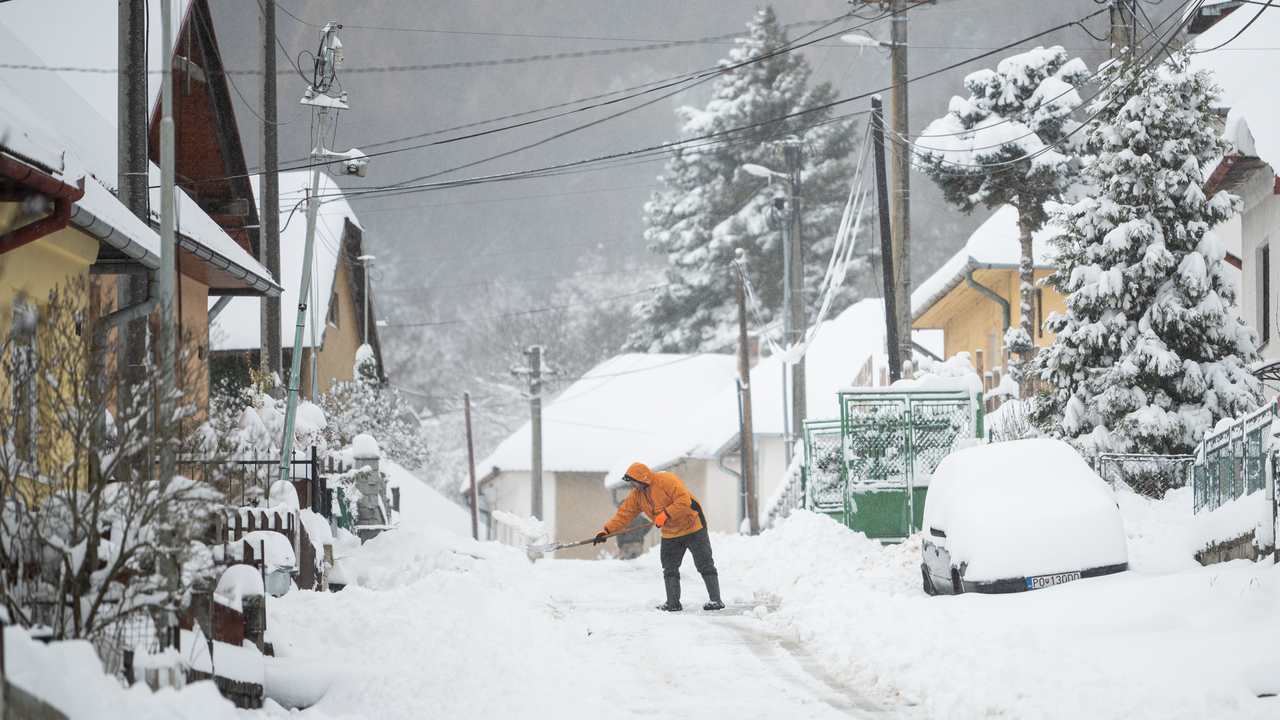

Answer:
[915,46,1088,386]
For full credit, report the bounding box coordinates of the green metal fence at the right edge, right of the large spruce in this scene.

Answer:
[1193,404,1276,512]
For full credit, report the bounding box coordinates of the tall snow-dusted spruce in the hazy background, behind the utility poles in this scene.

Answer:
[626,8,860,352]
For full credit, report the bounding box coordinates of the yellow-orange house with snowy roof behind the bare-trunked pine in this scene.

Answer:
[911,205,1066,372]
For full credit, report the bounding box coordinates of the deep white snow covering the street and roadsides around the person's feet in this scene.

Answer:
[6,474,1280,720]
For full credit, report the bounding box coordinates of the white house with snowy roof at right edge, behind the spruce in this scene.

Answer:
[1192,5,1280,398]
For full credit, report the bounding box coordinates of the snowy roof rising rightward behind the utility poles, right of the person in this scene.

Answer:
[605,299,884,486]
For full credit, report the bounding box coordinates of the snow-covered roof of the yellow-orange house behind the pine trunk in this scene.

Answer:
[911,205,1061,319]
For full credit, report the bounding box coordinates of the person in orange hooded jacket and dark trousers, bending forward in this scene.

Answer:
[591,462,724,612]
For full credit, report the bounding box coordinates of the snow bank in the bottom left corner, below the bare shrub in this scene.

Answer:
[4,628,239,720]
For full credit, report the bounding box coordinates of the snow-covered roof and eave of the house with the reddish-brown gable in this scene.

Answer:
[0,0,276,293]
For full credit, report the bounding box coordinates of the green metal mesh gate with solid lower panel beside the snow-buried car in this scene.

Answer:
[840,388,983,538]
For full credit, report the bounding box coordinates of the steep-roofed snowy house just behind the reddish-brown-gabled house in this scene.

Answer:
[210,170,387,397]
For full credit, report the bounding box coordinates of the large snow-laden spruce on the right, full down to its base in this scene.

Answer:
[1036,53,1260,454]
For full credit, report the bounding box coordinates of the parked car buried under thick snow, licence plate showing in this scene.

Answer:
[920,439,1129,594]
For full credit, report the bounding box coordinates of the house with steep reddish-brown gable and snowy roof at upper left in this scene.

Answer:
[0,0,280,415]
